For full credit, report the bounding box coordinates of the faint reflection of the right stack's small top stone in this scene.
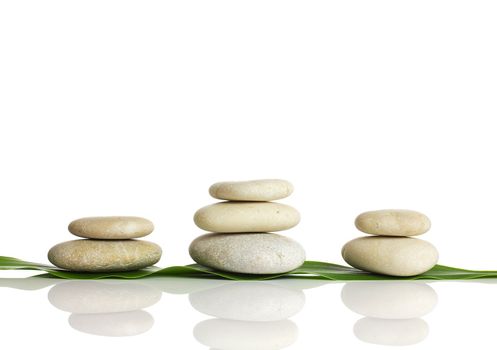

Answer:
[354,317,429,346]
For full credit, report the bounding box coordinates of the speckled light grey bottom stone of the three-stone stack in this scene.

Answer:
[190,233,305,274]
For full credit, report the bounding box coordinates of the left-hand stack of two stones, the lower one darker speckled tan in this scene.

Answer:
[48,216,162,272]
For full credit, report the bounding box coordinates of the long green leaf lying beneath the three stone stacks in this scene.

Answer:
[0,256,497,281]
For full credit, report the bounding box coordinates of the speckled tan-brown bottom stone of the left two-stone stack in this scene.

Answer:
[48,239,162,272]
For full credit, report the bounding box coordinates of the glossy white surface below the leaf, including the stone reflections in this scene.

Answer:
[0,278,497,350]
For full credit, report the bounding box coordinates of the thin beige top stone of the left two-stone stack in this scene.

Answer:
[68,216,154,239]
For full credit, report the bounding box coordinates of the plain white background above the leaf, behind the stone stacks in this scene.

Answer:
[0,0,497,348]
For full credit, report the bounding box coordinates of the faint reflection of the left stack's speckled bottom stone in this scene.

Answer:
[48,280,162,314]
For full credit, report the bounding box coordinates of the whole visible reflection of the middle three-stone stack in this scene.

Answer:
[189,281,305,350]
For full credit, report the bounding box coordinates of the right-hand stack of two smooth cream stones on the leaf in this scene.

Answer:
[342,210,438,276]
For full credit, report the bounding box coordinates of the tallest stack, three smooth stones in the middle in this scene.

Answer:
[190,180,305,274]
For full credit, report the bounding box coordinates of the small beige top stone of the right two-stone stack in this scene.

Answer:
[355,209,431,236]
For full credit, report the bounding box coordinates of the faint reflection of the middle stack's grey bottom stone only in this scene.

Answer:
[190,282,305,322]
